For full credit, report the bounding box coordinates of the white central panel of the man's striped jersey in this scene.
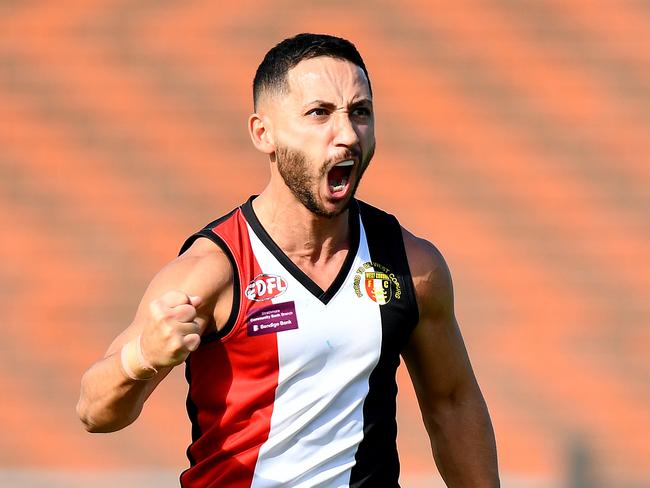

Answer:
[249,223,382,488]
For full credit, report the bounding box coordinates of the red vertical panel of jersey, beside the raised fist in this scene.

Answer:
[181,210,278,488]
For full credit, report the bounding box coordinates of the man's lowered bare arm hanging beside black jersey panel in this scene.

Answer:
[403,231,499,488]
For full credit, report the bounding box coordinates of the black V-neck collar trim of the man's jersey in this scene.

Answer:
[241,195,360,305]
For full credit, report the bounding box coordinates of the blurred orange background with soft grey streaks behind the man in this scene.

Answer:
[0,0,650,488]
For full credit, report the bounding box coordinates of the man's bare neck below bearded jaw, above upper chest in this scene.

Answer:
[253,185,350,262]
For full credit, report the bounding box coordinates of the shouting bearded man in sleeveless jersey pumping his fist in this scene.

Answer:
[77,34,499,487]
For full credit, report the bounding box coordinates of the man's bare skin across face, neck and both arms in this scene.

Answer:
[77,57,499,488]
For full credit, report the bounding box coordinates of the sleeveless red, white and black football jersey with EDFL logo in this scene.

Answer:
[181,197,418,488]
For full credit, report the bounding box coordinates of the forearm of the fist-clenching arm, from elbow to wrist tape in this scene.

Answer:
[77,353,162,432]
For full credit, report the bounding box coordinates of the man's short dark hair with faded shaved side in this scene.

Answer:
[253,33,372,110]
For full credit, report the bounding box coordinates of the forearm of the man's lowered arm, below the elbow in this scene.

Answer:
[424,387,500,488]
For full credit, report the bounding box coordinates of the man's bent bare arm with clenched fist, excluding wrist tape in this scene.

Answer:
[77,239,232,432]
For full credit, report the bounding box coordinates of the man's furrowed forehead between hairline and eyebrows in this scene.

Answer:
[287,56,371,102]
